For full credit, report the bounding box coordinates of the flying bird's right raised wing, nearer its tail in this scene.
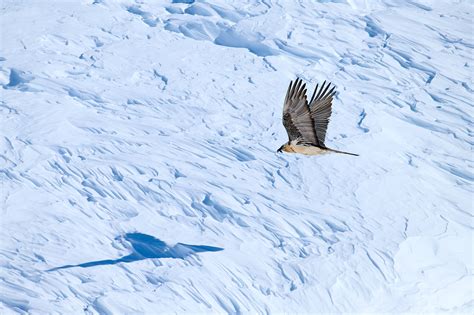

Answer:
[309,81,336,147]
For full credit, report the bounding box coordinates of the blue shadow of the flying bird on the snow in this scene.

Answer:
[47,233,223,271]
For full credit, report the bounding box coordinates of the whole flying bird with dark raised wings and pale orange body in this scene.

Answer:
[277,78,358,156]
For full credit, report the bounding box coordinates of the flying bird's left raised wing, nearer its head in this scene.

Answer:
[283,79,319,145]
